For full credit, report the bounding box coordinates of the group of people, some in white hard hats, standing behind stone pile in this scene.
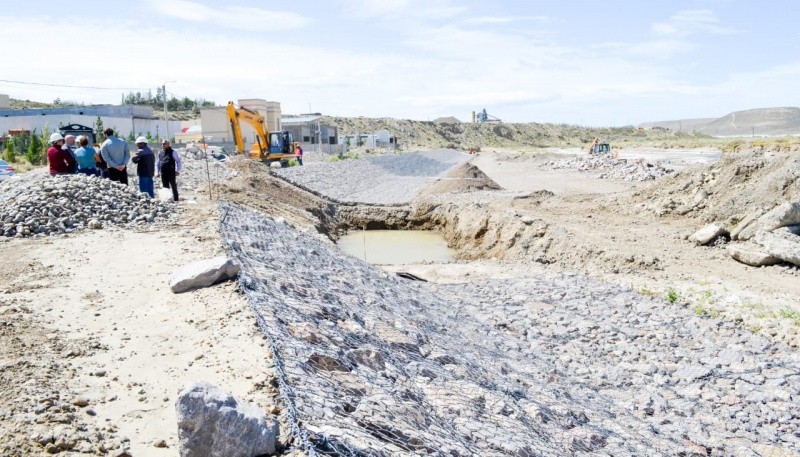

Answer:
[47,128,183,201]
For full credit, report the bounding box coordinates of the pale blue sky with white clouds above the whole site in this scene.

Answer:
[0,0,800,127]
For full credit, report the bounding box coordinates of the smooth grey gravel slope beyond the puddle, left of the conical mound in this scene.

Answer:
[274,149,471,205]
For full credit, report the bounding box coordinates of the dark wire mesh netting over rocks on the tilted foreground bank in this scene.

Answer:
[221,202,692,456]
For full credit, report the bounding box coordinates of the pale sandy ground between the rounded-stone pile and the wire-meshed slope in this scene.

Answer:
[0,202,282,456]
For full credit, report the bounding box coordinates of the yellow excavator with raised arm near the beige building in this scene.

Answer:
[228,102,295,166]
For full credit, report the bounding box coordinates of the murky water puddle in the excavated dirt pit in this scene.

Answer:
[336,230,453,265]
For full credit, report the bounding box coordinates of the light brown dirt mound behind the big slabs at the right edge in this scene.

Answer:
[629,151,800,225]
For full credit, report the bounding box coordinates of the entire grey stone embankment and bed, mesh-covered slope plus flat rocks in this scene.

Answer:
[221,203,800,456]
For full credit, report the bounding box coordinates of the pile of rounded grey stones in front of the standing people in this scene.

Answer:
[0,170,173,237]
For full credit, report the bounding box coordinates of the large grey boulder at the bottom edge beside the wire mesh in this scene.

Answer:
[175,383,278,457]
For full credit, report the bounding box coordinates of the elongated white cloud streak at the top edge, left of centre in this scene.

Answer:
[148,0,311,32]
